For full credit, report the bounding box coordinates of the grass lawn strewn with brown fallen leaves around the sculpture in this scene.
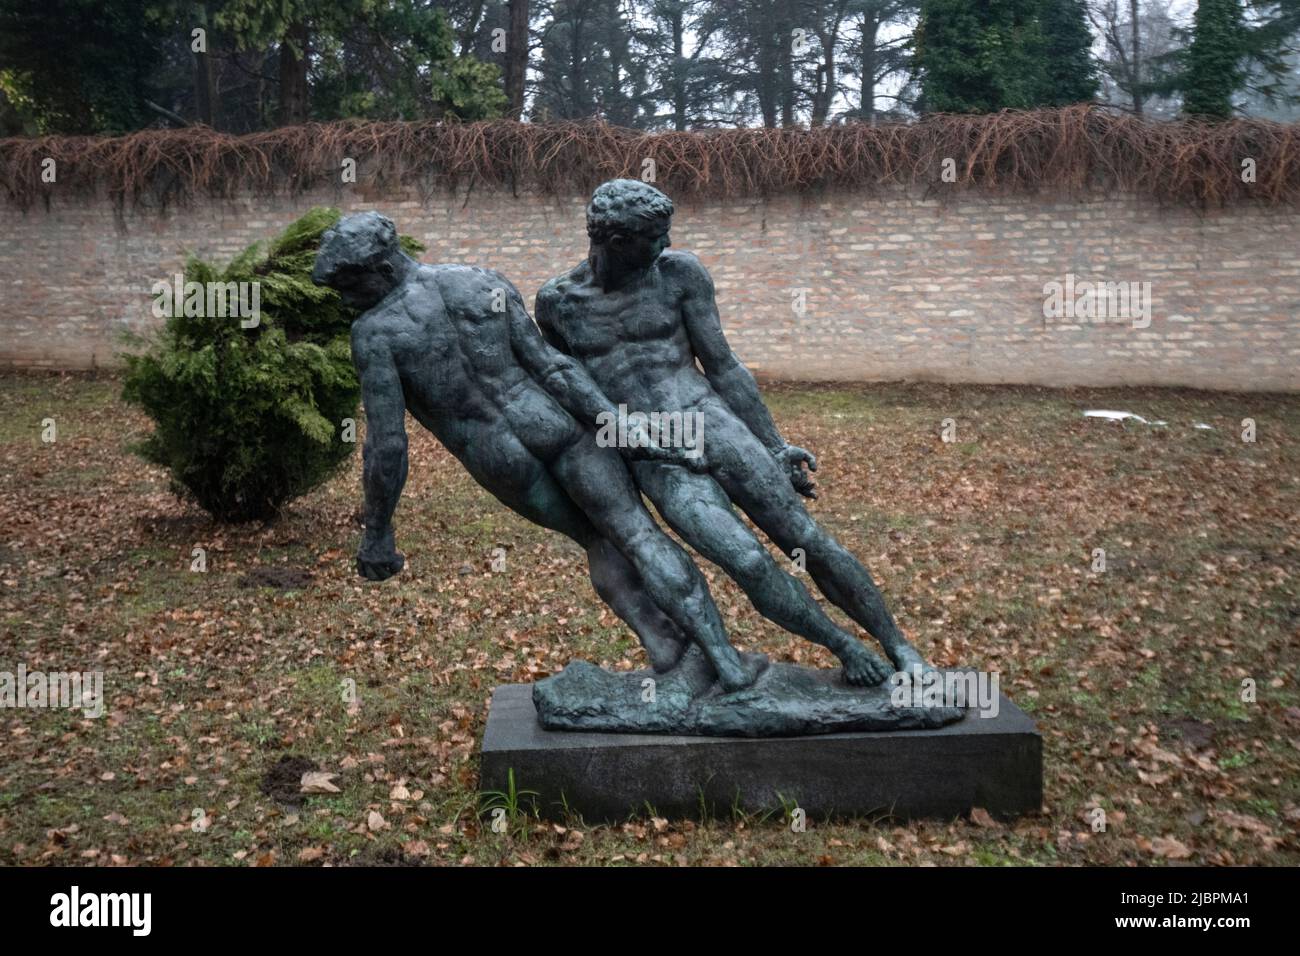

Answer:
[0,373,1300,865]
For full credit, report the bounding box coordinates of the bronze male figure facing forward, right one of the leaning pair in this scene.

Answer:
[536,179,924,684]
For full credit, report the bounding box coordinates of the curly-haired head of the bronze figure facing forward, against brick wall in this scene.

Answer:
[586,179,672,287]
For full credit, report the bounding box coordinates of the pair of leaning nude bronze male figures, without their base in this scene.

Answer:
[313,181,923,691]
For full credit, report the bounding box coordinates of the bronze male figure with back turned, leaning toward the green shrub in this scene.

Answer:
[312,212,766,691]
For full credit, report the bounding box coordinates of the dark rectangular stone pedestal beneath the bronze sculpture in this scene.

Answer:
[480,684,1043,822]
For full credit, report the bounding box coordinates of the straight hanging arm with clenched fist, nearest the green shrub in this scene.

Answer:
[352,325,407,581]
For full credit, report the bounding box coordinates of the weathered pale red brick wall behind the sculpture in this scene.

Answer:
[0,189,1300,390]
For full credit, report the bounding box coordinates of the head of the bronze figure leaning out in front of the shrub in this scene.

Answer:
[312,212,411,310]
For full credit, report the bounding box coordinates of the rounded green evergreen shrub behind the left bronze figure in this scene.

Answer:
[122,207,420,522]
